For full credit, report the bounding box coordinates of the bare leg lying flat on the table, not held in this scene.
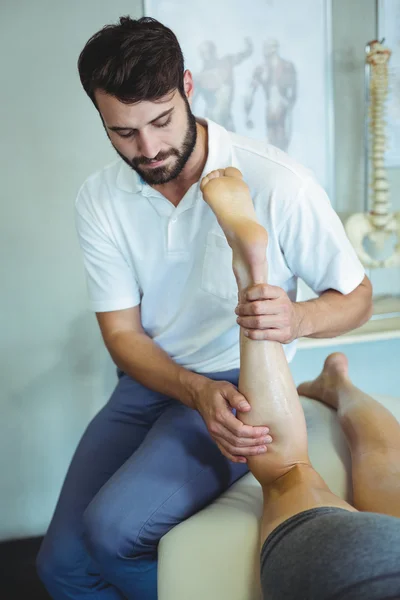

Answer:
[298,353,400,517]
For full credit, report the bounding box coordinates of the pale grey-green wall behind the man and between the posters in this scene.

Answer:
[0,0,400,539]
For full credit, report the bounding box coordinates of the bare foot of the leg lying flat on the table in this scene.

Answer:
[297,352,350,409]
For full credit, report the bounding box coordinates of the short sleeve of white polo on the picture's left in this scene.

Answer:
[75,186,140,312]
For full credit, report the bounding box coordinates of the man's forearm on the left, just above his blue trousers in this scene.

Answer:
[106,331,207,408]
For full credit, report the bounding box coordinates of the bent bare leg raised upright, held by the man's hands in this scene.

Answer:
[201,167,355,543]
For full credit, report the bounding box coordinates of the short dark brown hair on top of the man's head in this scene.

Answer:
[78,17,184,108]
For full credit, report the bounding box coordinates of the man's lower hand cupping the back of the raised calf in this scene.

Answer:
[194,379,272,463]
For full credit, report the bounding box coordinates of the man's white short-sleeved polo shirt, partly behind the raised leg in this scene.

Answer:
[76,120,365,373]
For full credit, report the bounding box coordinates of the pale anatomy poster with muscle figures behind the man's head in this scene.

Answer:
[145,0,333,192]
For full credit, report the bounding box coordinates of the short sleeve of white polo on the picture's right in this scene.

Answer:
[279,178,365,294]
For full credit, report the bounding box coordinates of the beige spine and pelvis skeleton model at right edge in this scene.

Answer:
[345,40,400,268]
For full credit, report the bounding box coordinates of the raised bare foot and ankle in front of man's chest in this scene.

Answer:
[200,167,268,291]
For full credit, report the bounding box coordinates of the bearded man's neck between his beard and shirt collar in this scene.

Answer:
[152,123,208,206]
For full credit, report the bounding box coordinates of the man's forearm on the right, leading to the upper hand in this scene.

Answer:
[295,277,372,338]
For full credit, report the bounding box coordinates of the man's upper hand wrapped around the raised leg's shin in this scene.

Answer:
[235,284,302,344]
